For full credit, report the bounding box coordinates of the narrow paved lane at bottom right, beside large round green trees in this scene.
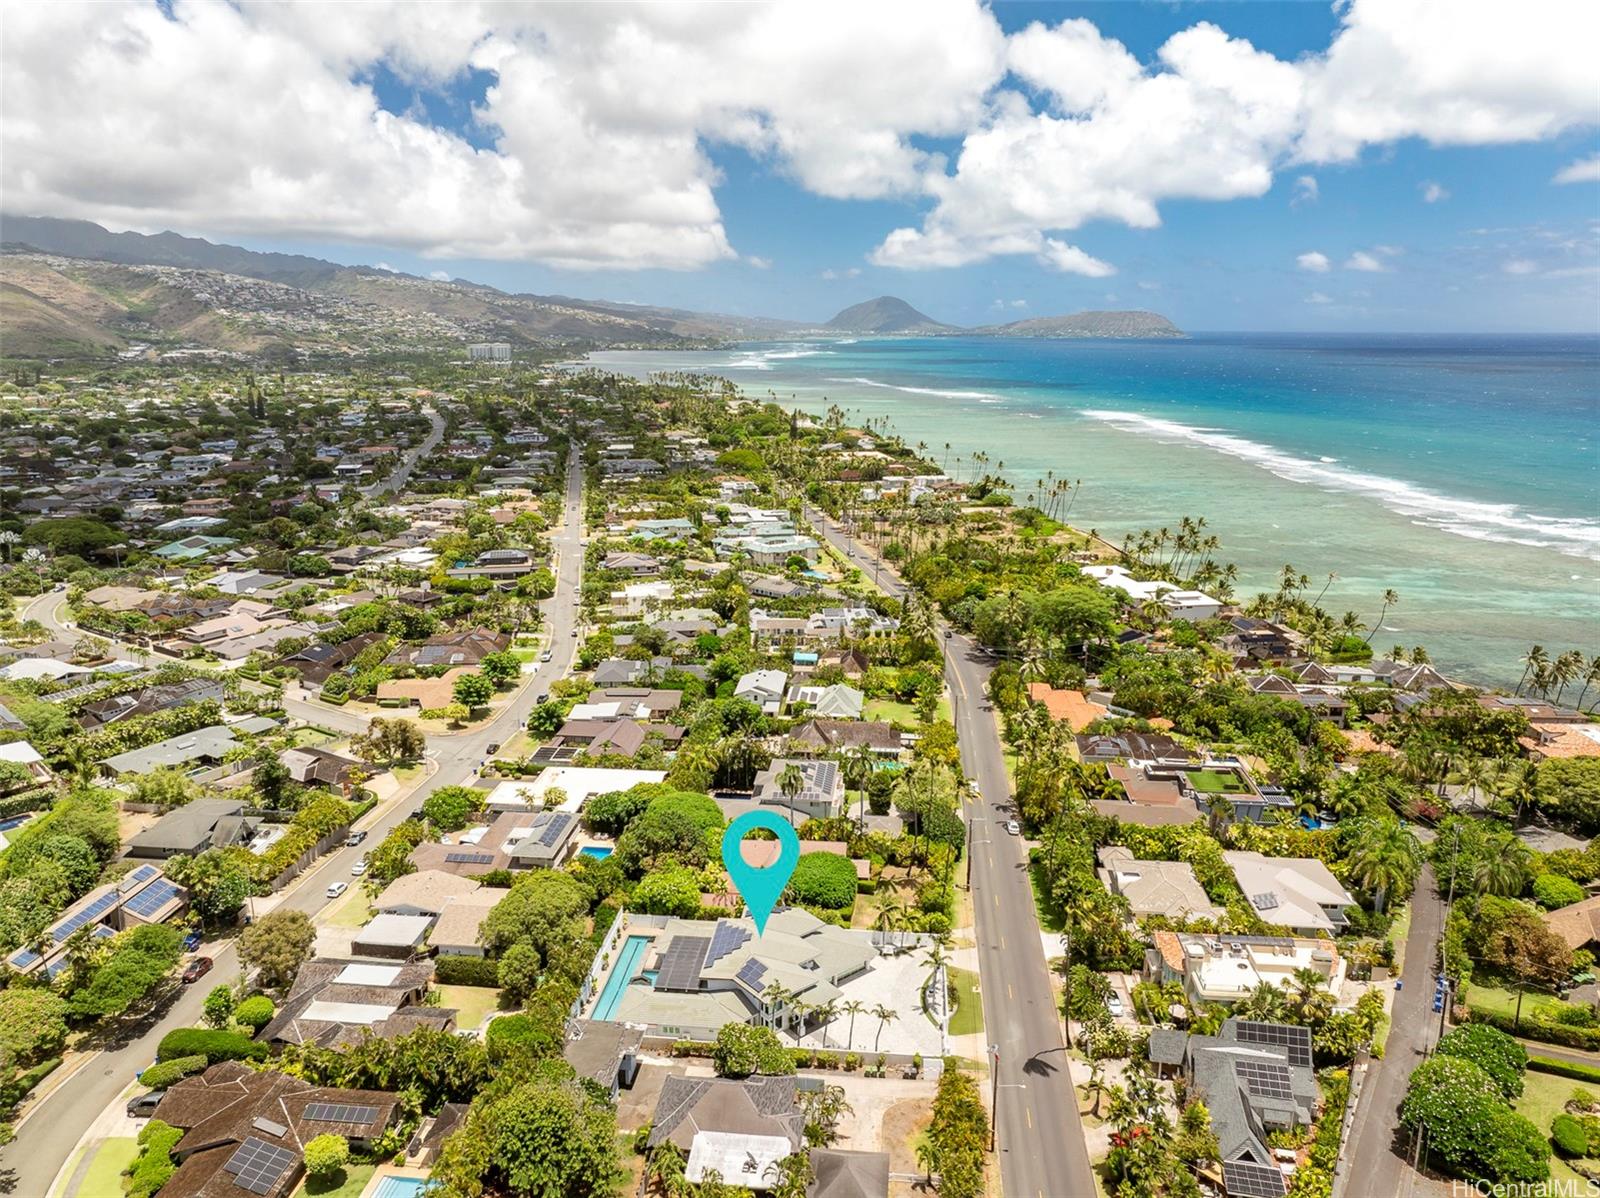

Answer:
[1338,865,1445,1198]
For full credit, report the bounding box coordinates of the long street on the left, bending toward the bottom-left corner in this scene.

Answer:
[0,448,584,1198]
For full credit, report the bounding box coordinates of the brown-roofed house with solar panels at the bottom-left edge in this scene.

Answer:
[158,1060,400,1198]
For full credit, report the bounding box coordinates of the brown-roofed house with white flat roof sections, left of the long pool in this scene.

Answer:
[259,958,456,1049]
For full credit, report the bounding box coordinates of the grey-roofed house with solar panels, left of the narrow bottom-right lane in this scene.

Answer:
[1150,1019,1318,1198]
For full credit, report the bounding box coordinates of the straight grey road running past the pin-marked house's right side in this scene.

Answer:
[808,510,1096,1198]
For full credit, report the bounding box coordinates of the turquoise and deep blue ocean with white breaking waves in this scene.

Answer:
[590,334,1600,699]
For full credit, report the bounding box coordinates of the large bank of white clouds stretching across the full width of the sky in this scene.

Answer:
[0,0,1600,278]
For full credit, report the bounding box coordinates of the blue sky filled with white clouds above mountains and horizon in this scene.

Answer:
[0,0,1600,333]
